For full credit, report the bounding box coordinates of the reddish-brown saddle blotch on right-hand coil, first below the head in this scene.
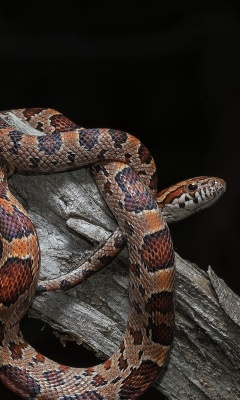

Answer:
[141,225,174,272]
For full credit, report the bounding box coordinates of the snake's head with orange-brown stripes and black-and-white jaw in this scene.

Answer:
[157,176,226,223]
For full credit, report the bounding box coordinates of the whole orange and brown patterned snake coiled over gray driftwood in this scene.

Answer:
[0,108,226,400]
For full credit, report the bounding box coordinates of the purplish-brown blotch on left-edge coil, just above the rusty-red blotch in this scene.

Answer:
[0,205,34,242]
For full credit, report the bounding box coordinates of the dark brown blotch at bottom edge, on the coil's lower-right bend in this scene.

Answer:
[119,360,161,400]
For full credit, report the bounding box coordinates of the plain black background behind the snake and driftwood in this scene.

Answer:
[0,0,240,399]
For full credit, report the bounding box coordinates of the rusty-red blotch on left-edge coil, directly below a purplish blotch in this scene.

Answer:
[0,257,33,307]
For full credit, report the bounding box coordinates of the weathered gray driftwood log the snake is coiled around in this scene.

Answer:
[10,168,240,400]
